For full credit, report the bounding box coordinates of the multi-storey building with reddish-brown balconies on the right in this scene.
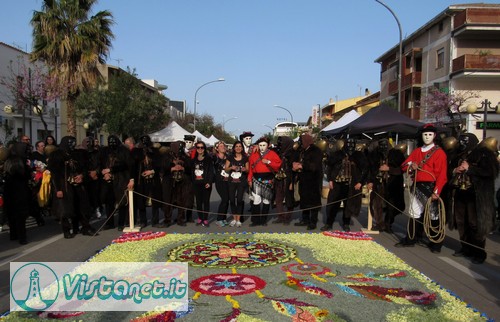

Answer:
[375,3,500,139]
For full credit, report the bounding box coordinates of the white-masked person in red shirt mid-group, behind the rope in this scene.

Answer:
[248,137,281,227]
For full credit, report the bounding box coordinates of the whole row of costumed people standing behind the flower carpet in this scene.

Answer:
[0,124,499,263]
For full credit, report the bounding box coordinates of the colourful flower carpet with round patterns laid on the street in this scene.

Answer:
[4,231,487,322]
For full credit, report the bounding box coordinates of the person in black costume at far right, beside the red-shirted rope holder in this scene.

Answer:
[450,133,499,264]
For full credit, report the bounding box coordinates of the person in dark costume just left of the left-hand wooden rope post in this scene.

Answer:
[99,135,135,231]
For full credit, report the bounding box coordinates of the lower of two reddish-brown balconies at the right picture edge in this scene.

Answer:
[452,54,500,74]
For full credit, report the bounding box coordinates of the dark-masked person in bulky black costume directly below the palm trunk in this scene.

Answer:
[48,136,96,238]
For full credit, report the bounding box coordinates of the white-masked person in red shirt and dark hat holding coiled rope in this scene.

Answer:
[396,124,447,253]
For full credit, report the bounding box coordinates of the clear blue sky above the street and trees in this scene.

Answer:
[0,0,498,139]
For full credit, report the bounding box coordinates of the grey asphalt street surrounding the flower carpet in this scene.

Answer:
[0,196,500,320]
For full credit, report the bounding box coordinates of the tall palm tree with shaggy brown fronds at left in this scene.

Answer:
[31,0,114,136]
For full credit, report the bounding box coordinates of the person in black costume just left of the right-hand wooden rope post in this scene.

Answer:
[321,138,368,231]
